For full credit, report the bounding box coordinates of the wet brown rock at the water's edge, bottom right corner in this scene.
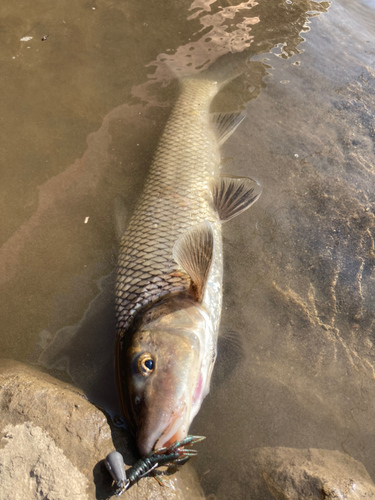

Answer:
[232,448,375,500]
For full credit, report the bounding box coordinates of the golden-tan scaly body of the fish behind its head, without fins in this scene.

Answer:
[116,80,221,337]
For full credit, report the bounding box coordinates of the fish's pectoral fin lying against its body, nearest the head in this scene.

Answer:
[173,222,214,300]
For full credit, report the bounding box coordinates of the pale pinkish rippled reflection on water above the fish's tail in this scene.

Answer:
[132,0,329,111]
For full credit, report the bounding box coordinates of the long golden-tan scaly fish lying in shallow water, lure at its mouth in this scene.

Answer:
[115,78,262,456]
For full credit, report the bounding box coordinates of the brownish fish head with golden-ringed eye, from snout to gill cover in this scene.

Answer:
[120,298,212,456]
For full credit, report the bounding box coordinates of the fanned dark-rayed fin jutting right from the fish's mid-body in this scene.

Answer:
[212,175,262,222]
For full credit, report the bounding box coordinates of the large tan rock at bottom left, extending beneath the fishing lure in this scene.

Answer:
[0,360,204,500]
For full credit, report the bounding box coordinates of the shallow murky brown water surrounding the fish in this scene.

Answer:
[0,0,375,498]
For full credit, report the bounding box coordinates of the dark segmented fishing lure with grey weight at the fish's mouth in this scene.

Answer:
[105,436,205,497]
